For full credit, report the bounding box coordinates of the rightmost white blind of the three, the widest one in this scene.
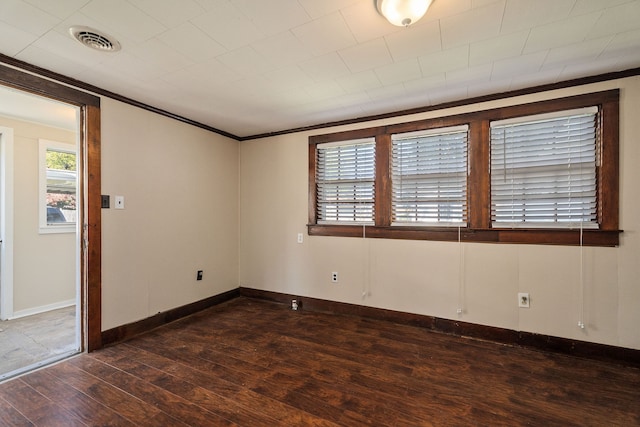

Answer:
[491,107,598,228]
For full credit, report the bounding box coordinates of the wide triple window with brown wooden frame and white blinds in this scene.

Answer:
[308,90,620,246]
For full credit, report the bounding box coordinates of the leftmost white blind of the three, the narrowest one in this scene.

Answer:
[316,138,376,223]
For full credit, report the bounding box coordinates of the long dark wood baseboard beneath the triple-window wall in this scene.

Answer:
[239,287,640,368]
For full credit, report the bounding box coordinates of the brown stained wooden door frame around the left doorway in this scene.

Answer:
[0,61,102,351]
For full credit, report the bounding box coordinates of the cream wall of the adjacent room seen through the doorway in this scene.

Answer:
[0,117,76,315]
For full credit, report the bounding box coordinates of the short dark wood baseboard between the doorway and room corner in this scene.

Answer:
[96,288,240,350]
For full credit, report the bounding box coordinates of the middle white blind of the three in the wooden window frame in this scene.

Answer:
[391,125,469,226]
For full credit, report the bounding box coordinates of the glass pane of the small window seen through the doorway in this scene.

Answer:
[46,149,77,226]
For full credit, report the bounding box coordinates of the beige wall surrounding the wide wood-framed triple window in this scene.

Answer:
[239,77,640,349]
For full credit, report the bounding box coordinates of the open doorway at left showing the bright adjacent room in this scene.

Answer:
[0,88,82,380]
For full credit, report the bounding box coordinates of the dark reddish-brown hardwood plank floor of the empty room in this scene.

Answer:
[0,297,640,427]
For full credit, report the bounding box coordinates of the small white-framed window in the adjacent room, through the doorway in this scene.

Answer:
[39,139,78,233]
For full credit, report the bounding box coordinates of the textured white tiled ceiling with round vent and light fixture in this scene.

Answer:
[0,0,640,137]
